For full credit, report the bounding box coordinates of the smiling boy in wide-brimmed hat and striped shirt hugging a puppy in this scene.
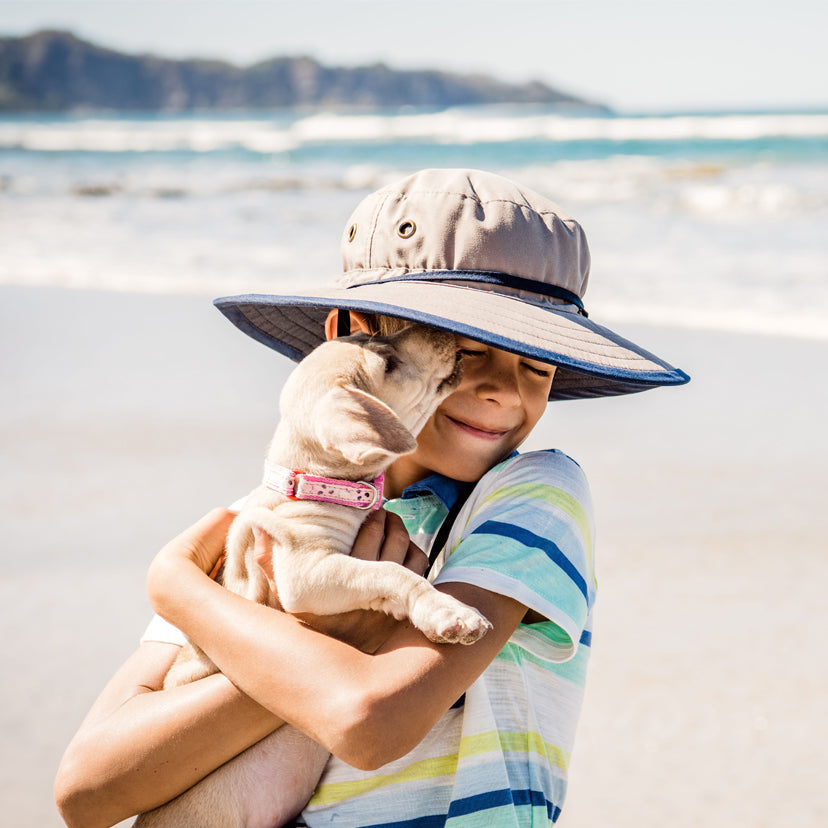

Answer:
[51,170,688,826]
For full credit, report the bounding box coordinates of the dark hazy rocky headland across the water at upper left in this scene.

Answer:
[0,31,608,112]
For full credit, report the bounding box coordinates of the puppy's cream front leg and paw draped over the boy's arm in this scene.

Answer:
[274,550,492,644]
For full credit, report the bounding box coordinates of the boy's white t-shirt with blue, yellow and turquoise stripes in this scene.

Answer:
[302,451,595,828]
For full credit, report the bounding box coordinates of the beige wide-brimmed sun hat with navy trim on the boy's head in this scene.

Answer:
[214,169,689,400]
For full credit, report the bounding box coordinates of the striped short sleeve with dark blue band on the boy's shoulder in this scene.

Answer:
[434,450,596,661]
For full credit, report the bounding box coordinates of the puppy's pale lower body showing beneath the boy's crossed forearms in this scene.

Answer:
[133,725,330,828]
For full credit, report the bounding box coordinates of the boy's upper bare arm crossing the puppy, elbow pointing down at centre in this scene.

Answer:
[148,512,526,768]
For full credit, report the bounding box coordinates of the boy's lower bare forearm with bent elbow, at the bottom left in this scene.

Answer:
[55,656,281,828]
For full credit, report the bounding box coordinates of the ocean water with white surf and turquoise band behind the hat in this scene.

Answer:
[0,107,828,339]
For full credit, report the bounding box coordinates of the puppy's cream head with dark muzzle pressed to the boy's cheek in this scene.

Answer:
[277,325,461,476]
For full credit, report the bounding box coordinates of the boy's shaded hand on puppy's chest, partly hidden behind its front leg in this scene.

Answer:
[256,509,428,653]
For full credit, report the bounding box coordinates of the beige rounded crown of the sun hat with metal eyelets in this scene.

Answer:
[338,170,590,312]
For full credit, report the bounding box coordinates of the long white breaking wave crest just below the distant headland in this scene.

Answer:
[0,108,828,155]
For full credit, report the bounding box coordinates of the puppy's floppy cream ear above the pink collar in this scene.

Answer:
[314,384,417,465]
